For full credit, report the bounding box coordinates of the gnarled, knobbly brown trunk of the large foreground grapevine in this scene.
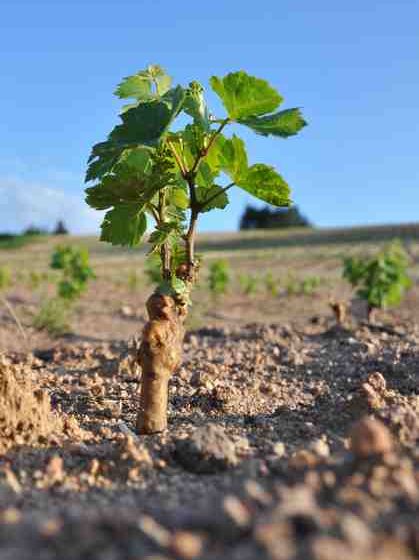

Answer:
[137,293,186,434]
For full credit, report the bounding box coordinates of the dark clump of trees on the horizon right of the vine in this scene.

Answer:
[240,205,311,230]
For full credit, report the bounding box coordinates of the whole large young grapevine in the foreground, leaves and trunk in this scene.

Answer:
[86,66,306,433]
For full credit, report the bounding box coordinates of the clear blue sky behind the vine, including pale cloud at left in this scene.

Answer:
[0,0,419,232]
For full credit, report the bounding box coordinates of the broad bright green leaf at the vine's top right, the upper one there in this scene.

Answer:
[210,71,282,120]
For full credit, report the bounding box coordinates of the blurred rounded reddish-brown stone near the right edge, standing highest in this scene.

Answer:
[350,416,394,459]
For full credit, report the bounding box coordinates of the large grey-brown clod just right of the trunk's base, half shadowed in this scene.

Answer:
[175,424,238,474]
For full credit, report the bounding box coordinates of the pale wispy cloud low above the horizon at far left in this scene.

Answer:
[0,176,101,233]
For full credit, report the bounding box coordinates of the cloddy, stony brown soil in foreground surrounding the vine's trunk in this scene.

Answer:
[0,317,419,560]
